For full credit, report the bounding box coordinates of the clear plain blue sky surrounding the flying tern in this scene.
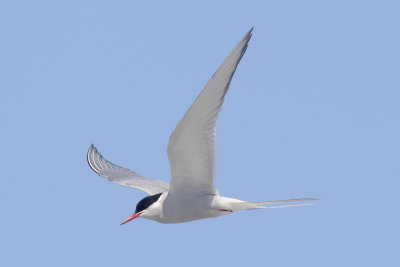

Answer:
[0,0,400,267]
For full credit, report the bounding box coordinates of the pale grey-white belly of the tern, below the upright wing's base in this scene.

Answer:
[159,195,220,223]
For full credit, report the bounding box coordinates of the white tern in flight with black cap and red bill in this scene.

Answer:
[87,28,317,225]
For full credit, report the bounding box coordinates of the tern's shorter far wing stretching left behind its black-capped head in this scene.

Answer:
[87,145,169,195]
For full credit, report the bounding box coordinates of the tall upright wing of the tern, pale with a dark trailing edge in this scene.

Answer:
[167,29,253,197]
